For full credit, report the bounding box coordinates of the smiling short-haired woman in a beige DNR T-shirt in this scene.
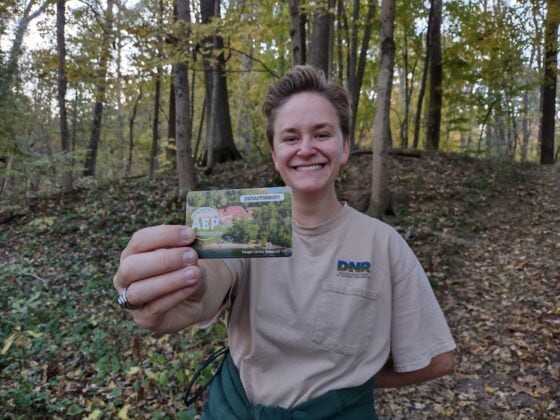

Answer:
[114,66,455,419]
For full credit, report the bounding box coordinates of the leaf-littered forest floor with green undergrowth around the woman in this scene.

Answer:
[0,154,560,419]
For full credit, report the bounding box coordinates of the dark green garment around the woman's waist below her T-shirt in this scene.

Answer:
[201,353,377,420]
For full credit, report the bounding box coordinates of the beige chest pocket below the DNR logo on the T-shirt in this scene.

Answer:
[311,285,378,356]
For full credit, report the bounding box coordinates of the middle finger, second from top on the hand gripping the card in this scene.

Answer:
[115,247,198,290]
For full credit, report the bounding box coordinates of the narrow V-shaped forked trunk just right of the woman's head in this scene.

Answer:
[346,0,377,146]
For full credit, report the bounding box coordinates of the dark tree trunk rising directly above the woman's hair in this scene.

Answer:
[310,0,335,79]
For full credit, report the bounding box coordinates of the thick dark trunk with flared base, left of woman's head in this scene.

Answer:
[201,0,241,172]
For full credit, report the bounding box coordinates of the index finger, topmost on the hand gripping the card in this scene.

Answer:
[121,225,196,261]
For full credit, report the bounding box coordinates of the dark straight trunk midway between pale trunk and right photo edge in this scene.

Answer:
[426,0,443,150]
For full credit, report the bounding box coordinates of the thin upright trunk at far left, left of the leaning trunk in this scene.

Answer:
[56,0,72,191]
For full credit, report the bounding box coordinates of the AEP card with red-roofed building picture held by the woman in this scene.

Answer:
[186,187,292,258]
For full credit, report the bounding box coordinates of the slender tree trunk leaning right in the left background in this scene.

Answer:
[84,0,114,176]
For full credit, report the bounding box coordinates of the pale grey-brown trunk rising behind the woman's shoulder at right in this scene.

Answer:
[367,0,395,218]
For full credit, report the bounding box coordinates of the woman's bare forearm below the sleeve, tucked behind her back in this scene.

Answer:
[374,351,454,388]
